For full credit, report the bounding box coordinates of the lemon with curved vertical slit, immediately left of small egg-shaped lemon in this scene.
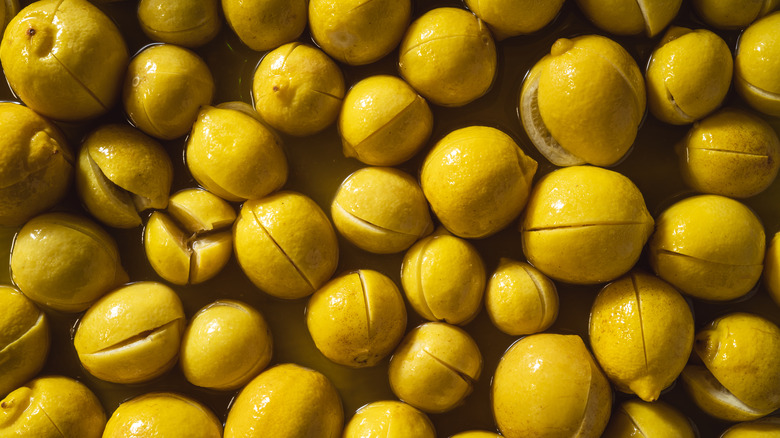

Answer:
[401,228,485,325]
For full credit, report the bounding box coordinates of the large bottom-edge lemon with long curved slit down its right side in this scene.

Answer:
[491,333,612,438]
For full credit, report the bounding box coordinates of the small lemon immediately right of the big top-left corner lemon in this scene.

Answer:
[122,44,214,140]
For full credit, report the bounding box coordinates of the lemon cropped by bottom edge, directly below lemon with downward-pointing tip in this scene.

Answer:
[602,400,698,438]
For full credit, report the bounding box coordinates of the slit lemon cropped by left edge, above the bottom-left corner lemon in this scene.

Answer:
[0,286,49,398]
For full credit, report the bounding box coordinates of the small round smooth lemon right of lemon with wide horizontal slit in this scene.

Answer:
[179,300,273,390]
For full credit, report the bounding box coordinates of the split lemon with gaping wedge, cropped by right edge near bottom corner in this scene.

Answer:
[682,313,780,421]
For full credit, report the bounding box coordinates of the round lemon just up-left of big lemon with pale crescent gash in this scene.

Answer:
[398,8,497,107]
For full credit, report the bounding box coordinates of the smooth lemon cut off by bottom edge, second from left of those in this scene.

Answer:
[225,364,344,438]
